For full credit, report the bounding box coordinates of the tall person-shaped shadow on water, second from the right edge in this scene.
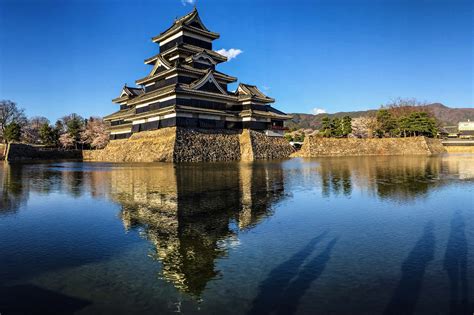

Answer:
[385,222,435,314]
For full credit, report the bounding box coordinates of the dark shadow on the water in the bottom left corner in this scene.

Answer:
[0,284,91,314]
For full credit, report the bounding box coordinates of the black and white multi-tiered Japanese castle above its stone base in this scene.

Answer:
[104,9,291,140]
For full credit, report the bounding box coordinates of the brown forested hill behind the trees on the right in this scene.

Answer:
[287,103,474,129]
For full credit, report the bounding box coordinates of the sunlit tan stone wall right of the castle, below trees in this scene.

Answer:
[295,136,446,157]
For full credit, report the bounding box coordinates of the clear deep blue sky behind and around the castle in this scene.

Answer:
[0,0,474,120]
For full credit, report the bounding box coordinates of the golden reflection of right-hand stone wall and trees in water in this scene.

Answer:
[312,156,474,202]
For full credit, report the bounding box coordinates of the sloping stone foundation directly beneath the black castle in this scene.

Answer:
[83,127,294,162]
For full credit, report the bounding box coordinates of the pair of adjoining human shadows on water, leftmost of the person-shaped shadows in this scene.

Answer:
[248,231,337,314]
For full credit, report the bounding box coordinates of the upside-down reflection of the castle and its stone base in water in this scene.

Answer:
[110,163,284,296]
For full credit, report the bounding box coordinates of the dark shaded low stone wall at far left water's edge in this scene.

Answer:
[5,143,82,162]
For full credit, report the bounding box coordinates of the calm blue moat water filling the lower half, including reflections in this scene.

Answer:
[0,154,474,315]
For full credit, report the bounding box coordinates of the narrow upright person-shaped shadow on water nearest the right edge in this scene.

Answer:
[444,211,469,314]
